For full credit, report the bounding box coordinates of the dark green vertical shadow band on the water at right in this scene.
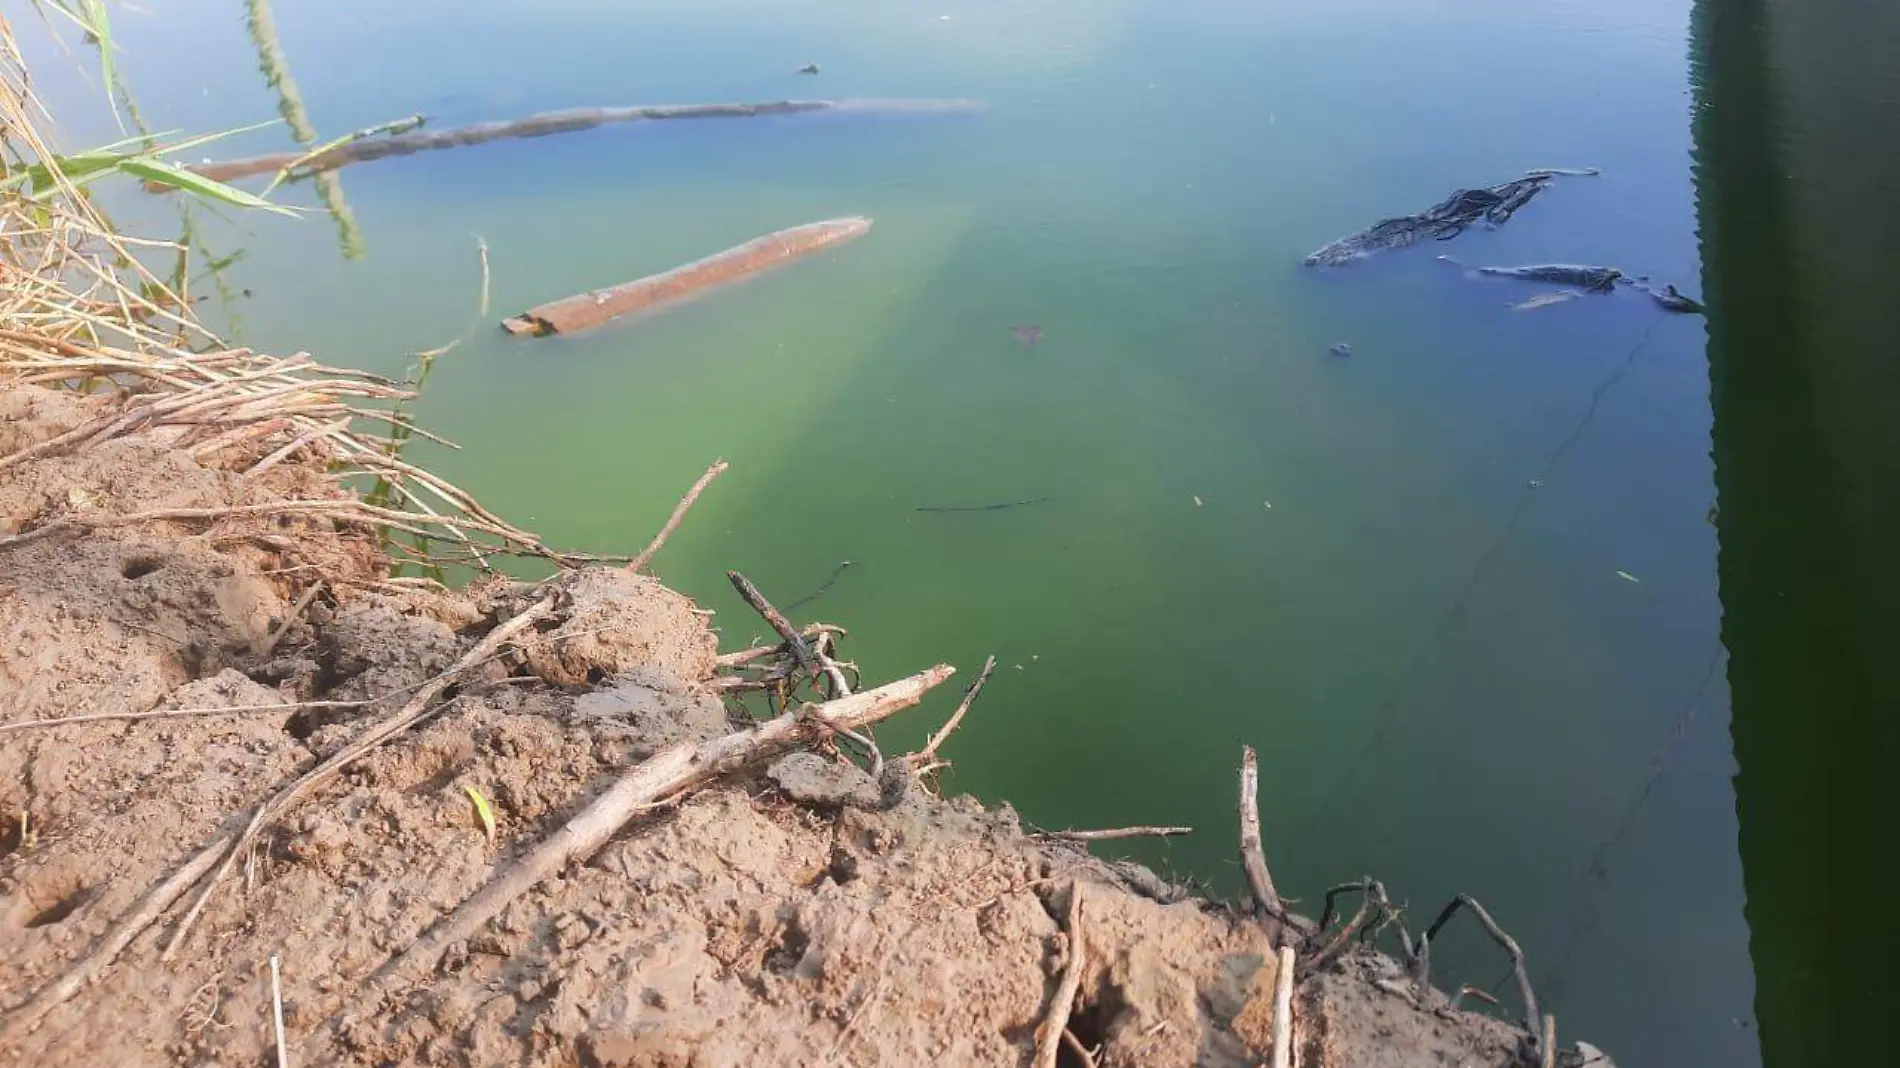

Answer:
[1691,0,1900,1068]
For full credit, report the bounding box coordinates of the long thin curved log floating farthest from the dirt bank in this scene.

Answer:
[157,99,982,192]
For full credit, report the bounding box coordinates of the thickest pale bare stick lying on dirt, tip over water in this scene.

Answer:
[378,663,956,984]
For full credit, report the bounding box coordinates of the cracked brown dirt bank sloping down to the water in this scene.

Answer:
[0,378,1588,1068]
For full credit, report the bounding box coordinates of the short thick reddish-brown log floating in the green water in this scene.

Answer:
[502,215,870,336]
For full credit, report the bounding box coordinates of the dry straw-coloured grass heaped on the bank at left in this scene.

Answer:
[0,19,595,568]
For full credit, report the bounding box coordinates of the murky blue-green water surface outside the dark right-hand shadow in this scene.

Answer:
[25,0,1839,1066]
